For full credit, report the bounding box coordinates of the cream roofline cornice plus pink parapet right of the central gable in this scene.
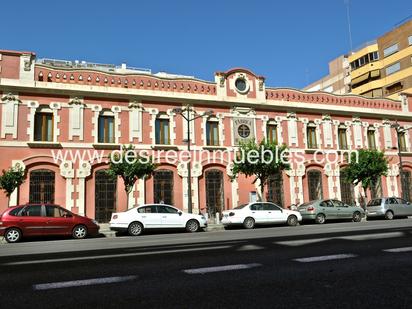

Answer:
[0,78,406,119]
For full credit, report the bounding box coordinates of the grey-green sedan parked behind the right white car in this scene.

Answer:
[298,199,365,224]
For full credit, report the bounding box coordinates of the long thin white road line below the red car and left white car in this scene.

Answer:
[2,246,231,266]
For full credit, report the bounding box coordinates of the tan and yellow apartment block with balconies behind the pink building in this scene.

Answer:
[304,20,412,99]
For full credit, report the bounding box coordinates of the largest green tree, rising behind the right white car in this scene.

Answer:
[231,140,290,199]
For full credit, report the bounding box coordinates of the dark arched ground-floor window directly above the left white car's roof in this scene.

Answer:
[153,170,173,205]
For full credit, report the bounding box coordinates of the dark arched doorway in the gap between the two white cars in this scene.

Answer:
[205,169,225,217]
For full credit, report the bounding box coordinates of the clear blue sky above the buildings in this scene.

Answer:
[0,0,412,88]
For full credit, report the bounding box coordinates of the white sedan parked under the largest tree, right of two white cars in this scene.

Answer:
[221,202,302,229]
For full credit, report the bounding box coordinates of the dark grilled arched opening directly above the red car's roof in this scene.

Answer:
[29,169,55,204]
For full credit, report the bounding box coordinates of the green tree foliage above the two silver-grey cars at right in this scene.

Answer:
[342,149,388,202]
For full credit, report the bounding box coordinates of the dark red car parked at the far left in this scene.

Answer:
[0,204,99,243]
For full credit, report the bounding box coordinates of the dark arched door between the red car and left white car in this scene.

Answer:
[95,170,117,223]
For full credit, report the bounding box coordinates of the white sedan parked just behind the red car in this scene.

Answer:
[110,204,207,236]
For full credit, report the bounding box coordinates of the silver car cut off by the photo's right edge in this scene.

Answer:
[366,197,412,220]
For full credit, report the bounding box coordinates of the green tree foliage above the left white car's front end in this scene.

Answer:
[107,145,156,194]
